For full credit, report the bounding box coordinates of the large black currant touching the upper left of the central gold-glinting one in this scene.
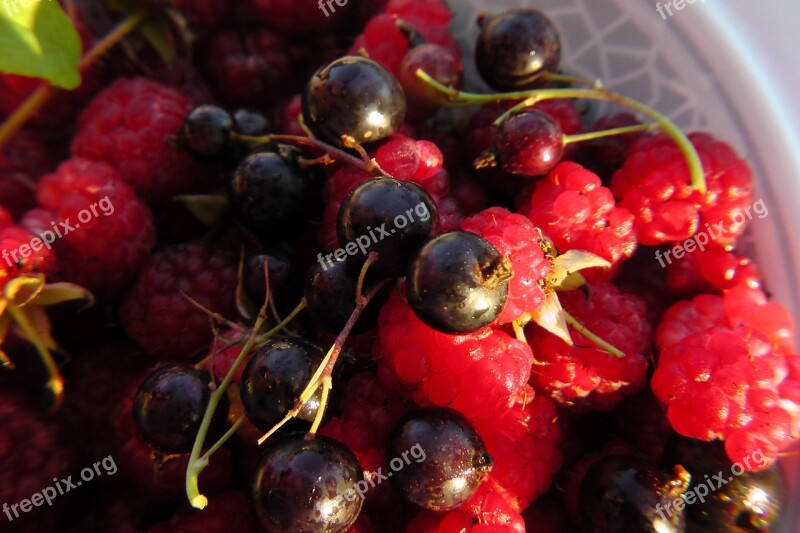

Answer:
[336,178,437,276]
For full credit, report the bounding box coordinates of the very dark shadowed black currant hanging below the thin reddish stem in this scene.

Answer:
[229,146,317,240]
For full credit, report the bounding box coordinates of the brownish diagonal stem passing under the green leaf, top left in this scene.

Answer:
[0,13,144,149]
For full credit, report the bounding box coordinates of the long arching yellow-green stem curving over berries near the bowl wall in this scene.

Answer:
[417,69,707,194]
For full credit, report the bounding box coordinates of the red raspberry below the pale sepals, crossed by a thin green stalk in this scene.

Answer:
[528,282,650,411]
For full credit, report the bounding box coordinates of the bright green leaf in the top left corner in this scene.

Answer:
[0,0,81,89]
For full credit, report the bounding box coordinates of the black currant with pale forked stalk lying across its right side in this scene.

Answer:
[239,337,325,431]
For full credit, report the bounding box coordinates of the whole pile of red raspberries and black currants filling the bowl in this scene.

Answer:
[0,0,800,533]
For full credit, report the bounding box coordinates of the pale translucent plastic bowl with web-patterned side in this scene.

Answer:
[450,0,800,533]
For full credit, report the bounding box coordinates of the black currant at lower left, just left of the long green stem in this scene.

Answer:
[133,364,228,454]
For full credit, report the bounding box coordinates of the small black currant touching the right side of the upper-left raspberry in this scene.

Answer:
[178,105,234,162]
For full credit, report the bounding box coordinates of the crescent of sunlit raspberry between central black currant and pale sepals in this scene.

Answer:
[461,207,552,324]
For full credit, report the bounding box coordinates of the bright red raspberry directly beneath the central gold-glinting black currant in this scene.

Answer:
[374,293,533,419]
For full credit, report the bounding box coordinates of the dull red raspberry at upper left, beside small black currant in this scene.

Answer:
[71,78,210,199]
